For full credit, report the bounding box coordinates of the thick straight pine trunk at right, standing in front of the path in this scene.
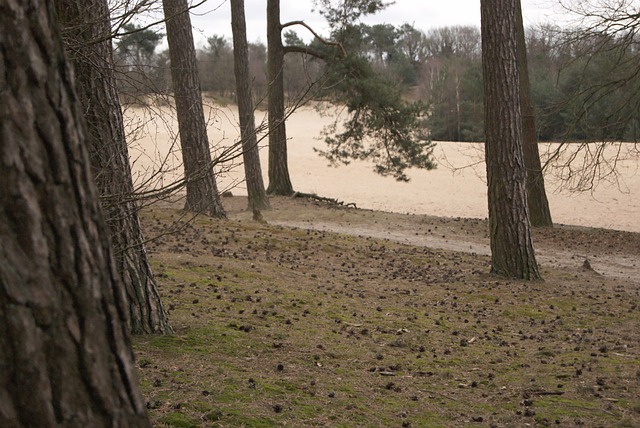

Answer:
[481,0,540,279]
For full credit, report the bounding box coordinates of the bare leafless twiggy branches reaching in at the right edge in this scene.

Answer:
[545,0,640,191]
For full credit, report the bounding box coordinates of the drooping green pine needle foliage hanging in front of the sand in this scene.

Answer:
[316,56,436,181]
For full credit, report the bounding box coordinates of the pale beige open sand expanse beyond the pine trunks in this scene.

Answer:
[125,101,640,232]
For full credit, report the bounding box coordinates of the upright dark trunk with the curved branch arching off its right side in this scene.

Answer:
[267,0,293,196]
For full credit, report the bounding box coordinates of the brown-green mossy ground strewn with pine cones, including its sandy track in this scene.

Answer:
[133,197,640,427]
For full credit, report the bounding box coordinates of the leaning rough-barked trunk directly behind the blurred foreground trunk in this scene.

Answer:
[55,0,171,334]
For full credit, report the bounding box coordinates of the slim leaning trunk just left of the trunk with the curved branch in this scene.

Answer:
[231,0,271,212]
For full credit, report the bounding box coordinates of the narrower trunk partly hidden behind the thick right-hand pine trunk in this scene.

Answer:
[516,0,553,227]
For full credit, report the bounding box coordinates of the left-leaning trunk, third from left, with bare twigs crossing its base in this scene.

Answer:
[162,0,226,217]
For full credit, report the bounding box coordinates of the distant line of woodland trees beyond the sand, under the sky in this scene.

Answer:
[115,24,640,141]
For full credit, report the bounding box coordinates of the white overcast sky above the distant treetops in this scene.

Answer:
[185,0,559,44]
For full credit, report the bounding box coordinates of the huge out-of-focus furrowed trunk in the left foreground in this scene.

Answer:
[0,0,150,427]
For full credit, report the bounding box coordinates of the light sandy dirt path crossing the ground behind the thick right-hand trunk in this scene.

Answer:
[227,197,640,281]
